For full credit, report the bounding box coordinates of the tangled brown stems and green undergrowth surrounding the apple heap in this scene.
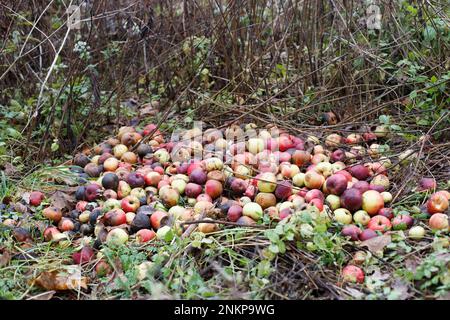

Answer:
[0,0,450,299]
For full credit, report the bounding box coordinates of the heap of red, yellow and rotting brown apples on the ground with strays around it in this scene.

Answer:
[22,124,450,282]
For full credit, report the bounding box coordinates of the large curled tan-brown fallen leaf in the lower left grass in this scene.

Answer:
[33,265,87,291]
